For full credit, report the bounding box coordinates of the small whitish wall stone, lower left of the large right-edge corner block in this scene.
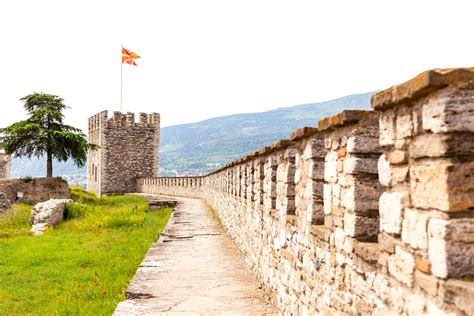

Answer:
[388,246,415,287]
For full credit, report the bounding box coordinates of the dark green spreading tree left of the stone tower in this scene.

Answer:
[0,93,98,177]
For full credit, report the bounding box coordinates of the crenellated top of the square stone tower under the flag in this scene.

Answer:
[89,111,160,131]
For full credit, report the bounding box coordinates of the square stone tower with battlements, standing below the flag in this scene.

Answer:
[87,111,160,196]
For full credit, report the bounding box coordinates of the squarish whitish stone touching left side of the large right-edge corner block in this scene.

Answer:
[402,209,428,249]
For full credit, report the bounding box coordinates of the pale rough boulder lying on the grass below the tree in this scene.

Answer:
[29,199,73,236]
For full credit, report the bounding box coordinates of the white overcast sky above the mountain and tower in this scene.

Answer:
[0,0,474,130]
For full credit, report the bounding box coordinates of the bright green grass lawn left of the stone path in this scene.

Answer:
[0,188,171,315]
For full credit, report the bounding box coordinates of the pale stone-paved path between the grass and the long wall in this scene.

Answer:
[115,198,276,315]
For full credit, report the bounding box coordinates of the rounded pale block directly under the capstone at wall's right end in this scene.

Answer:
[422,88,474,133]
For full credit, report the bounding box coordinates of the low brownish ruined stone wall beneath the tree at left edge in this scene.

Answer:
[0,178,69,204]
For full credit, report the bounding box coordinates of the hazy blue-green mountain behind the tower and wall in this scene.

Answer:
[12,92,373,179]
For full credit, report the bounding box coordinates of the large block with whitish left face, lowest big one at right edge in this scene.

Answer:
[428,218,474,278]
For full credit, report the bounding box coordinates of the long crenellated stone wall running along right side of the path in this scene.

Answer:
[139,69,474,315]
